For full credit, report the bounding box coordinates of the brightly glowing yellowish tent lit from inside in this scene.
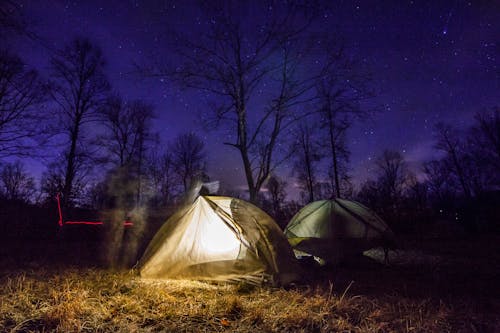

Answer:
[139,196,297,284]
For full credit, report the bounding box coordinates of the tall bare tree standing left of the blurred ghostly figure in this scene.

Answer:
[51,38,110,205]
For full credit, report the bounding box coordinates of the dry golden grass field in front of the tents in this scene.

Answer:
[0,237,500,332]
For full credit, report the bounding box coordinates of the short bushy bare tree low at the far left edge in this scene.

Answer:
[0,161,36,202]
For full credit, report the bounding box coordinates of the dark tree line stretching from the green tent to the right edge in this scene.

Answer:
[357,113,500,233]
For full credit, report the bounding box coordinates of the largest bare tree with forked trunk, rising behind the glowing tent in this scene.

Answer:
[148,2,332,201]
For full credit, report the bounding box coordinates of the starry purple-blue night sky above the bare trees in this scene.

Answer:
[7,0,500,192]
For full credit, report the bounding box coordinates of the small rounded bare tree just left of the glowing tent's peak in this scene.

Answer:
[169,133,206,192]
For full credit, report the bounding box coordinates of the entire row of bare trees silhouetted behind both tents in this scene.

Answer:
[0,2,500,233]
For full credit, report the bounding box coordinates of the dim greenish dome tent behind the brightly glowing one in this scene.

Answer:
[285,199,394,263]
